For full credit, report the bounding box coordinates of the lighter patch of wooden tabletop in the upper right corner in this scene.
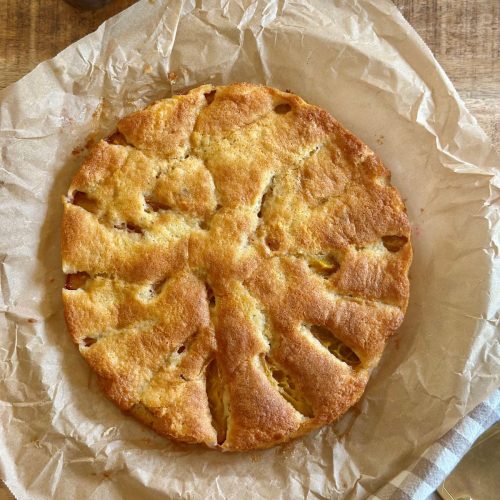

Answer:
[394,0,500,151]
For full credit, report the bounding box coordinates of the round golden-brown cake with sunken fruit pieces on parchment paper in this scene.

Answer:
[62,83,412,451]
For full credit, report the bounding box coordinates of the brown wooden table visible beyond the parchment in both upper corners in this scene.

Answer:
[0,0,500,150]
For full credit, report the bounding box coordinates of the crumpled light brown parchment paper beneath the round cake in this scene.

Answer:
[0,0,500,499]
